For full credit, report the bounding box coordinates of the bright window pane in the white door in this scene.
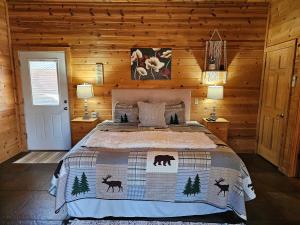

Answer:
[29,61,59,105]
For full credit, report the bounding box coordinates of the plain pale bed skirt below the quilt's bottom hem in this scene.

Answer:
[67,199,230,219]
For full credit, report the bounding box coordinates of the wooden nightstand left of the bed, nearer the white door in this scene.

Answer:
[71,117,99,145]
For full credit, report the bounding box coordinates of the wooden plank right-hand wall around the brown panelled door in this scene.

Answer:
[266,0,300,176]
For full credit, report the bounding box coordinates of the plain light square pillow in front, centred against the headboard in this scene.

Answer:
[138,102,167,127]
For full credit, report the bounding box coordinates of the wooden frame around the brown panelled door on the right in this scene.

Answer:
[255,39,297,173]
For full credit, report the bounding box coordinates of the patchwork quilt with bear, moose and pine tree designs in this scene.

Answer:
[51,122,255,219]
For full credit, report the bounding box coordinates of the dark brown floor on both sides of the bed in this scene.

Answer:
[0,154,300,225]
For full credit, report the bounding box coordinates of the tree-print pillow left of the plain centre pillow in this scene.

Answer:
[113,102,139,123]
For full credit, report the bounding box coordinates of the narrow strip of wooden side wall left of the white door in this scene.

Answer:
[0,0,19,163]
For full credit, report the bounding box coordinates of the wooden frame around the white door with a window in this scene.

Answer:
[13,46,74,151]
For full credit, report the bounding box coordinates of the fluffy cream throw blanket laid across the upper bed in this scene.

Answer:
[85,130,217,149]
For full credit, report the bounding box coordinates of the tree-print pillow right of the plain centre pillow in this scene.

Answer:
[165,102,185,124]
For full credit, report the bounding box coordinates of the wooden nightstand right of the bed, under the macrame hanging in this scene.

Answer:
[202,118,230,142]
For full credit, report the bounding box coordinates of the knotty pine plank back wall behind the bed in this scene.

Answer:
[9,1,267,152]
